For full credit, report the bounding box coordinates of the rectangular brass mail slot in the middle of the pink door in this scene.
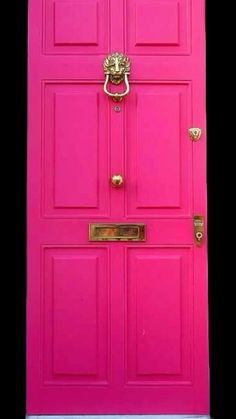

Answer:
[89,223,145,241]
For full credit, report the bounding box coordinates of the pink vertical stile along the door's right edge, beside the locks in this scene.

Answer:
[193,1,209,413]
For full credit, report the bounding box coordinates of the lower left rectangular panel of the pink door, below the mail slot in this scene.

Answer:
[41,246,109,385]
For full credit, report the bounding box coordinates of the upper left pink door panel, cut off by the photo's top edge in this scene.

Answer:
[43,0,109,54]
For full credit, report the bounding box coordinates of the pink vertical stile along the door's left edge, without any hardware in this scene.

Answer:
[26,2,42,405]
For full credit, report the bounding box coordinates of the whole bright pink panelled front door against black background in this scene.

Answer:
[27,0,208,415]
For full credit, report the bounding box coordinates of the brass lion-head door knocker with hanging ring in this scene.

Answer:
[103,52,130,102]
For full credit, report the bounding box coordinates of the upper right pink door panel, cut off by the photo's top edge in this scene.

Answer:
[126,0,191,55]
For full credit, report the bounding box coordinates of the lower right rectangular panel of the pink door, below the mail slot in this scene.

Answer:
[126,246,193,386]
